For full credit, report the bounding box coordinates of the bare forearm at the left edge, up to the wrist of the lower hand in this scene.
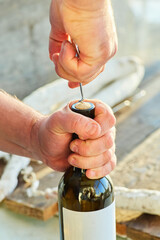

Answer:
[0,91,43,157]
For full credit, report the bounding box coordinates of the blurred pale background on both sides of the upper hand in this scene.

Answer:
[0,0,160,99]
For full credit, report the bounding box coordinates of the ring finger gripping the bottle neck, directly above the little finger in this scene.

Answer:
[68,149,113,171]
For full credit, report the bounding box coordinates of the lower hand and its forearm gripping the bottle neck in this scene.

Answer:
[0,91,116,178]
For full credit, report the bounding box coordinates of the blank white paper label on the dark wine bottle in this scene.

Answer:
[63,202,116,240]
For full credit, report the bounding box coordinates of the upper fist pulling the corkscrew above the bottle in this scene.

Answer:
[49,0,117,88]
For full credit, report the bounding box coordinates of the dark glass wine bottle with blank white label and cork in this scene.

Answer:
[58,102,116,240]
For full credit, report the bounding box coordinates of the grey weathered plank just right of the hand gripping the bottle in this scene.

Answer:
[116,76,160,161]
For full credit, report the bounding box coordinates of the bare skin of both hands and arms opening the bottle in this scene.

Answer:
[0,0,117,178]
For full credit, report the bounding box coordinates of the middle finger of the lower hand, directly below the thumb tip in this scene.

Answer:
[70,128,115,157]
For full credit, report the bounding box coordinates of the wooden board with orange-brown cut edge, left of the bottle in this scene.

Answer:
[4,162,62,220]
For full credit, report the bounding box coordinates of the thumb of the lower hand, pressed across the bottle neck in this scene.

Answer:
[49,104,101,140]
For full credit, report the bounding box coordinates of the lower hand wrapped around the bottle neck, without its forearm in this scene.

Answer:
[32,100,116,178]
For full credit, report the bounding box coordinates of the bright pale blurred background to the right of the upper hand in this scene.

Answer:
[113,0,160,64]
